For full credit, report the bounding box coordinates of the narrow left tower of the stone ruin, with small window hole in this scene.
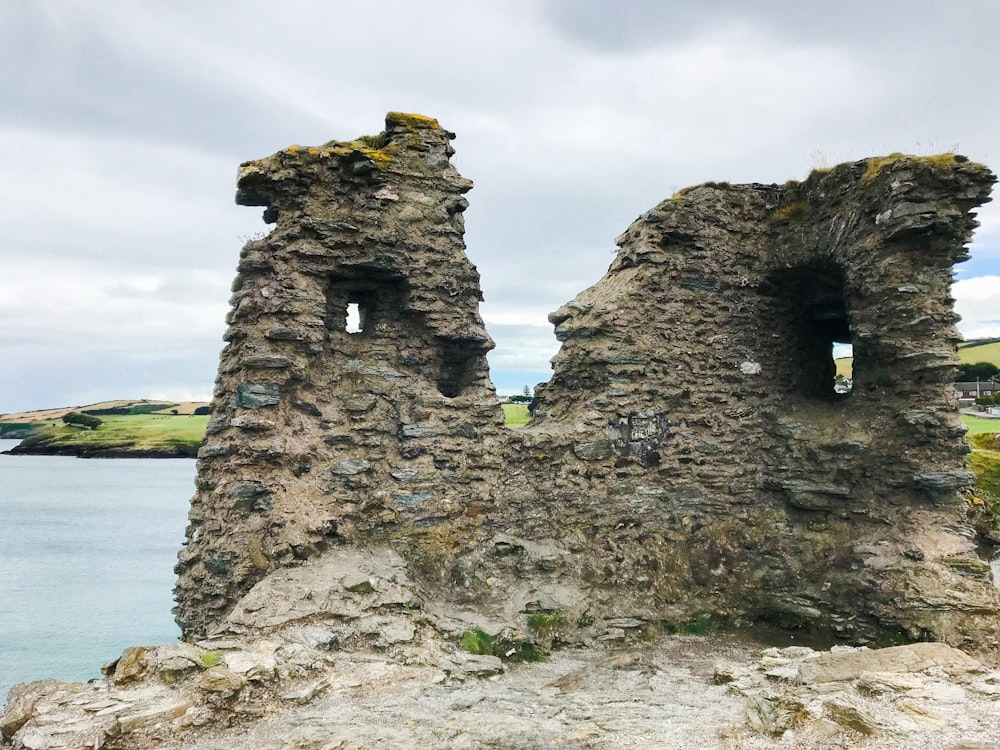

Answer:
[177,114,503,631]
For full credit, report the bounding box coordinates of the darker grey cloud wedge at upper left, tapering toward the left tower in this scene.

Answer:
[0,2,320,153]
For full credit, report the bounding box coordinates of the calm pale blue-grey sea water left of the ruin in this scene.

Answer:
[0,440,195,704]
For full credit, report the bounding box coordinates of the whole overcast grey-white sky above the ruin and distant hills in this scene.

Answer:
[0,0,1000,413]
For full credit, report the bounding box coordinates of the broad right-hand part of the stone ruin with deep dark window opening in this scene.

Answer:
[524,156,996,639]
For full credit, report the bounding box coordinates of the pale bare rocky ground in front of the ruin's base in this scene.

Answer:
[0,632,1000,750]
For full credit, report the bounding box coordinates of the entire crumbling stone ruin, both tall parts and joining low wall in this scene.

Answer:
[177,113,1000,651]
